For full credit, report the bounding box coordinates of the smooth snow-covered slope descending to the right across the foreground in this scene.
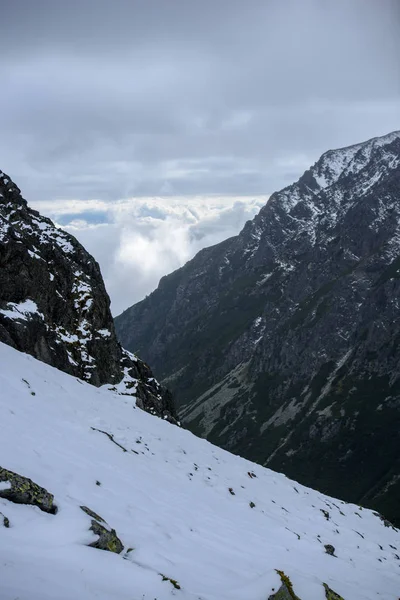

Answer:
[0,344,400,600]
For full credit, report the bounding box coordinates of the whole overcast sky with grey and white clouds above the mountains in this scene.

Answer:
[0,0,400,313]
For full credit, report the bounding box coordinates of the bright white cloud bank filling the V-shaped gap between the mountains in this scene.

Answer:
[33,195,268,315]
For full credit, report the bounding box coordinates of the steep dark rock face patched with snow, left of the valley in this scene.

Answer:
[0,171,174,421]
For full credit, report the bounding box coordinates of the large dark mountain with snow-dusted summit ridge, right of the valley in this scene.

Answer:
[115,132,400,523]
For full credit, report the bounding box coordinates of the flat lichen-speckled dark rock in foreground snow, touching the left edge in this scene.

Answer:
[0,467,57,515]
